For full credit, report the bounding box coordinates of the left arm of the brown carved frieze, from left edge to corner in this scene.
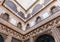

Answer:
[0,24,23,39]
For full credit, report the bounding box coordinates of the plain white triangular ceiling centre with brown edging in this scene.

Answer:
[16,0,39,11]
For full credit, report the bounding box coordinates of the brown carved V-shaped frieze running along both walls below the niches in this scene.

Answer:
[0,16,60,40]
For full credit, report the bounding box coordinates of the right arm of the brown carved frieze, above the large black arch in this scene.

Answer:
[24,16,60,39]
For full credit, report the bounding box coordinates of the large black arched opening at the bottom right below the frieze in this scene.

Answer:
[35,34,55,42]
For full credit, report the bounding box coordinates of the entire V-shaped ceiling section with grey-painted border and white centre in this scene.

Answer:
[3,0,55,23]
